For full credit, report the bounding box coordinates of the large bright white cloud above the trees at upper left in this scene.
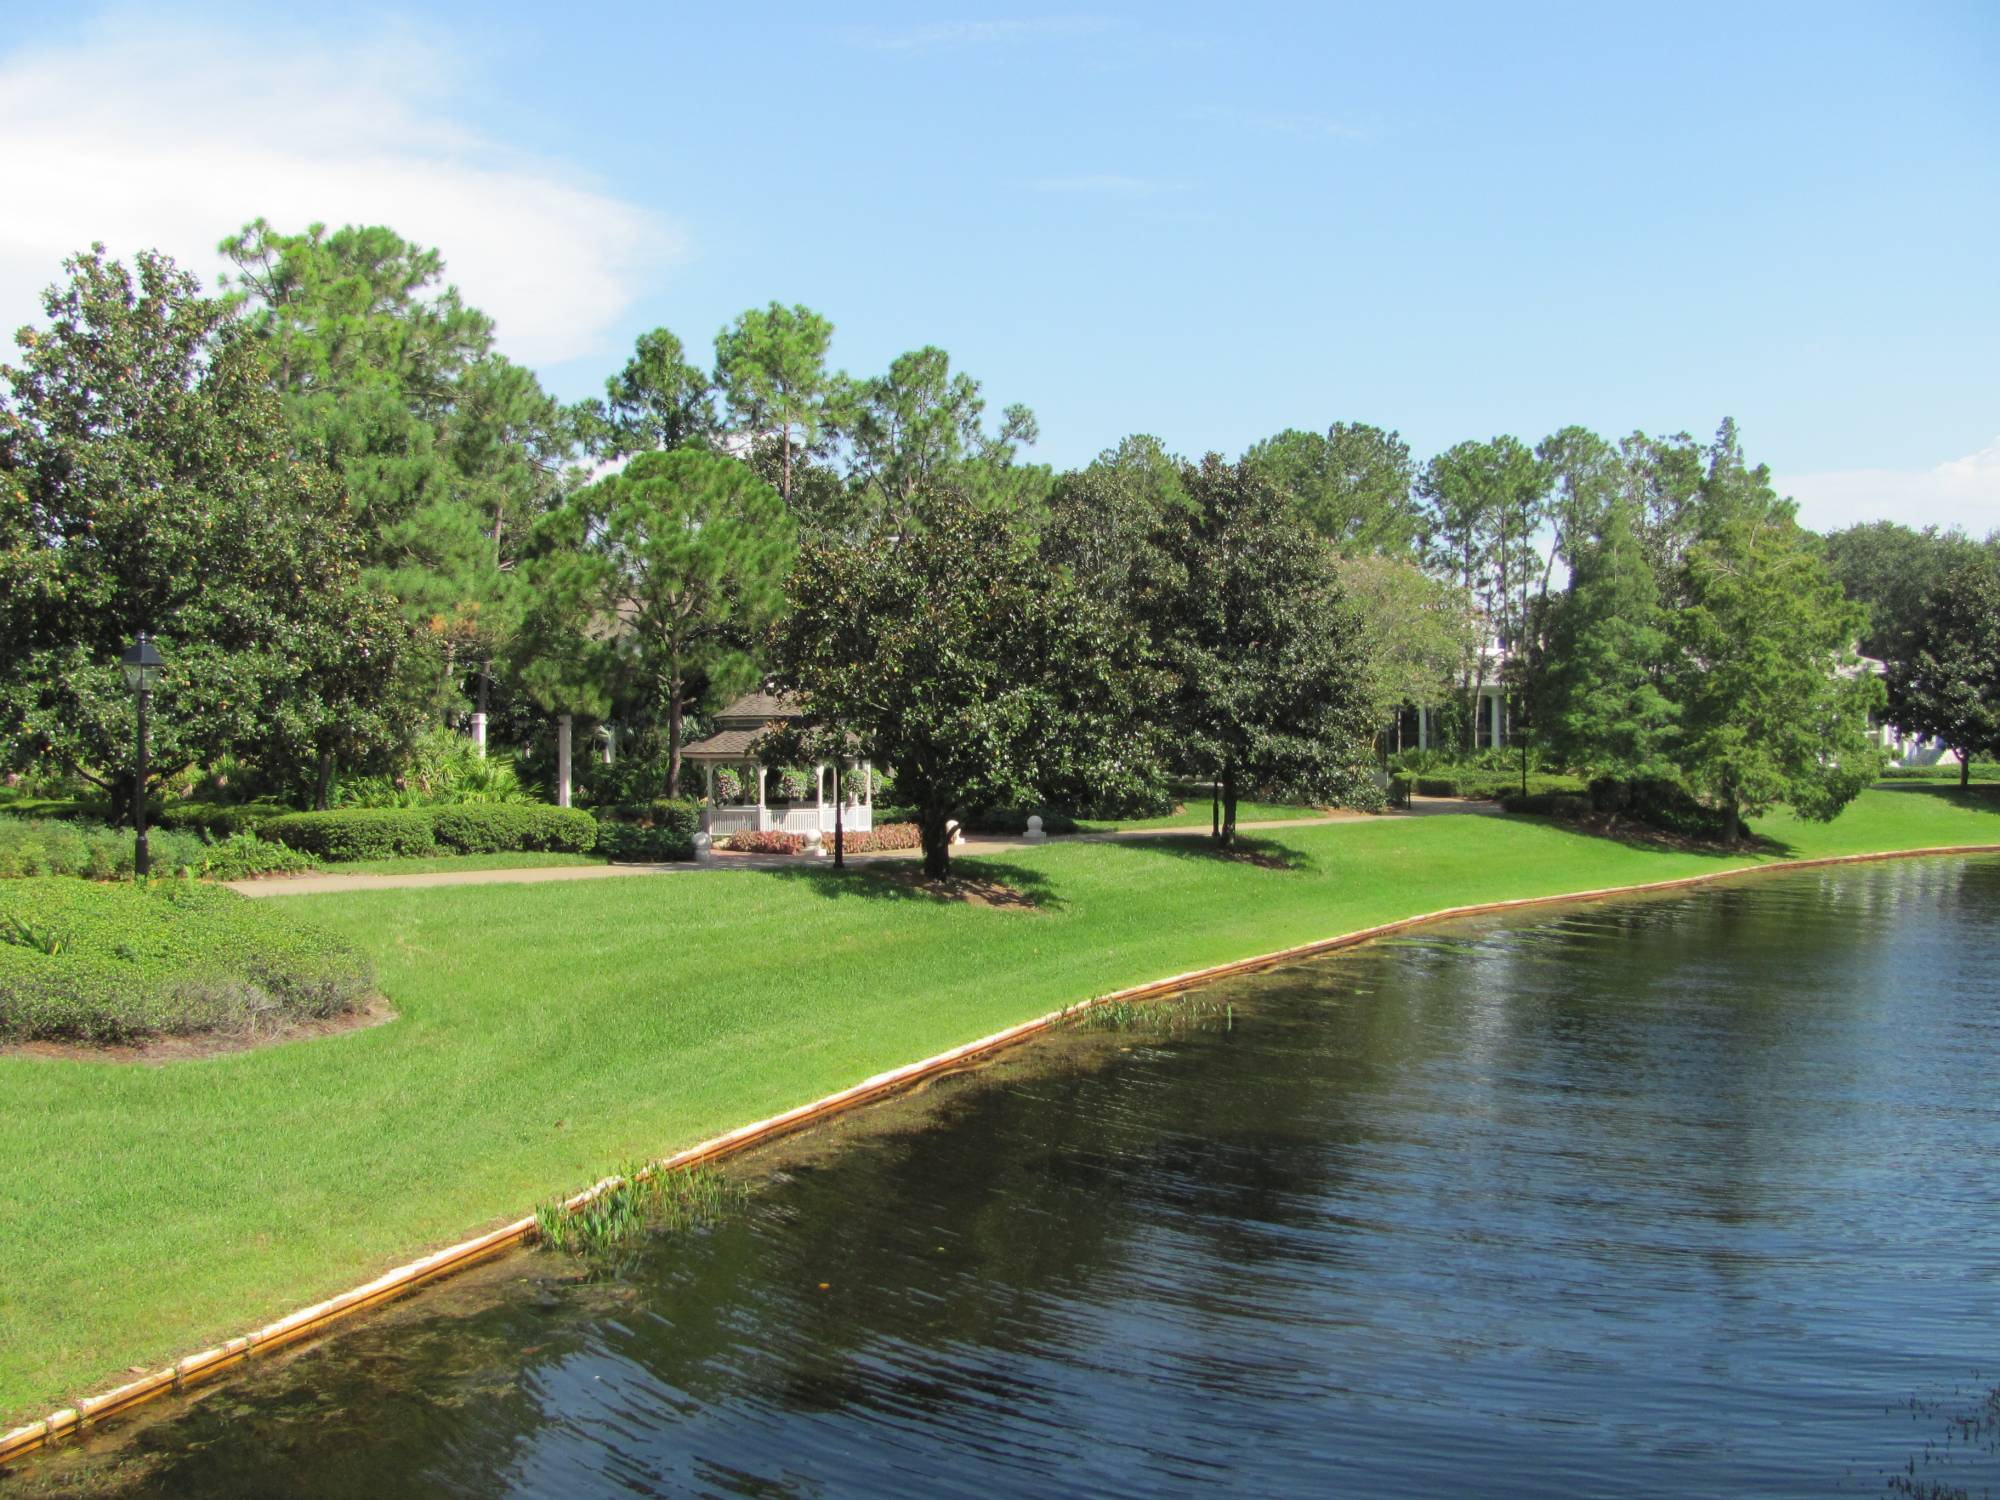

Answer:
[0,18,682,364]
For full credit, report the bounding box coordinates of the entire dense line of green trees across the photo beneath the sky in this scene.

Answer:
[0,220,2000,870]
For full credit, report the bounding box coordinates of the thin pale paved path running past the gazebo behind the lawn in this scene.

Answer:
[224,796,1494,896]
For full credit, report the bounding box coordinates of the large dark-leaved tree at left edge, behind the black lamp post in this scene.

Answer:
[0,250,400,792]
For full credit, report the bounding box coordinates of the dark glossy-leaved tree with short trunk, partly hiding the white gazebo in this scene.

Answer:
[772,482,1154,878]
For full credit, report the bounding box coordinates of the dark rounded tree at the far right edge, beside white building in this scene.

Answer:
[1888,550,2000,776]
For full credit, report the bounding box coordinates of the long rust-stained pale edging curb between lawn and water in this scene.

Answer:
[0,844,2000,1464]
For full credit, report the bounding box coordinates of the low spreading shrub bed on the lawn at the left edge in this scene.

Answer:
[0,880,374,1042]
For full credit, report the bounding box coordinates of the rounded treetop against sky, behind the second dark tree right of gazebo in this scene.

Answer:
[1244,422,1422,558]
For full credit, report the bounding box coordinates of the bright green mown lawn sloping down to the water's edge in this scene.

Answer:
[0,786,2000,1418]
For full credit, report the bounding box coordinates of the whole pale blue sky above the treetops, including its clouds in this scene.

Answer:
[0,4,2000,532]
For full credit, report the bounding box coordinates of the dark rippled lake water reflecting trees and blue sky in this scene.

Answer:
[15,860,2000,1500]
